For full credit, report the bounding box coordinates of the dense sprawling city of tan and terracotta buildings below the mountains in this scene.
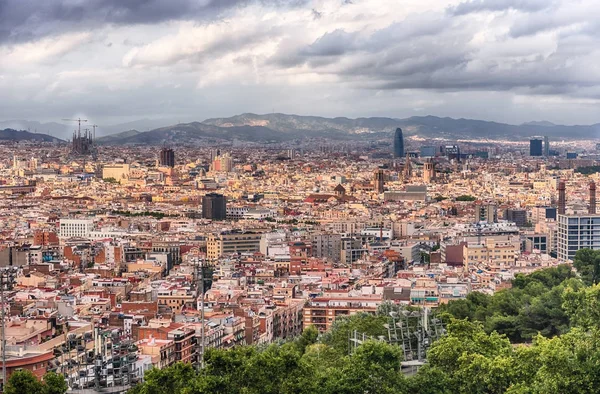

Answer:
[0,121,600,392]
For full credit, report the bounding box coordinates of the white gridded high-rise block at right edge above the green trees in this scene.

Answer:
[556,214,600,261]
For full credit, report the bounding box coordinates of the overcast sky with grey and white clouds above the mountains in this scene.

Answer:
[0,0,600,124]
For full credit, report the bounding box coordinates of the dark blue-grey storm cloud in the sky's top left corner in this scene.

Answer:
[0,0,306,44]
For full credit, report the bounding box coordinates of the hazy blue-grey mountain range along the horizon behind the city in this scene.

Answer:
[0,113,600,145]
